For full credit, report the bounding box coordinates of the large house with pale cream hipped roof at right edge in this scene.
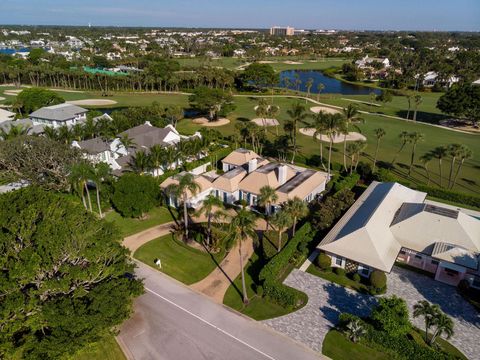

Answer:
[318,182,480,288]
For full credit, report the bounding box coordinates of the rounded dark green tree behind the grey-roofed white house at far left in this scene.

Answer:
[15,87,65,114]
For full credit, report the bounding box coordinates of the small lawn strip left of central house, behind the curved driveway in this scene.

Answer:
[105,206,175,237]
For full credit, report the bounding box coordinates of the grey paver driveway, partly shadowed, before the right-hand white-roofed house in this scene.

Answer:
[265,267,480,359]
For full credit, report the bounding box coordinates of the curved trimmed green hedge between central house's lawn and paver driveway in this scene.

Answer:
[259,223,314,307]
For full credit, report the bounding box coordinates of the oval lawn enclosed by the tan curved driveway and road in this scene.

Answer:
[133,235,225,285]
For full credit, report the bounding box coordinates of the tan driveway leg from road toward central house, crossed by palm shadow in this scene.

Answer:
[191,238,253,304]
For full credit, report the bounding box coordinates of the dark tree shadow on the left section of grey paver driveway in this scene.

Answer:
[320,283,377,326]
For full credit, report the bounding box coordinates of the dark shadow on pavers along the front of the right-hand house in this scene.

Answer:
[387,267,480,328]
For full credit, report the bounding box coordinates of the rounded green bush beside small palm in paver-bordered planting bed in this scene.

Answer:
[370,296,412,336]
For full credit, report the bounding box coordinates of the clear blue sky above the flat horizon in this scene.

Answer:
[0,0,480,31]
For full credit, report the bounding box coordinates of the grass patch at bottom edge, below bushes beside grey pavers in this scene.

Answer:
[322,330,392,360]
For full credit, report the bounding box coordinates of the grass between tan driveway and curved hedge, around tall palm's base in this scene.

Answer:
[223,249,308,321]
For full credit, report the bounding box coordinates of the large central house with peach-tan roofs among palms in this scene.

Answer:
[160,148,328,212]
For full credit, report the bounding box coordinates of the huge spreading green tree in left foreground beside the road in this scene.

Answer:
[0,186,143,359]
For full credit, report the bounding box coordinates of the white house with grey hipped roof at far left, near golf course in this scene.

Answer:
[29,104,88,128]
